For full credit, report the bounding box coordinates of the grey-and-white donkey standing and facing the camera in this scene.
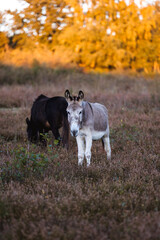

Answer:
[65,90,111,167]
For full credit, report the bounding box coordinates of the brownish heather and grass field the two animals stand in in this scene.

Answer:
[0,70,160,240]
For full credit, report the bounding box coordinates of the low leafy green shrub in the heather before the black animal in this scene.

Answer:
[0,145,57,182]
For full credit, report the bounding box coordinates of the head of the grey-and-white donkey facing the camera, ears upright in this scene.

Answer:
[65,90,84,137]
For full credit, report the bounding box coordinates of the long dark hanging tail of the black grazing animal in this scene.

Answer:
[62,113,69,150]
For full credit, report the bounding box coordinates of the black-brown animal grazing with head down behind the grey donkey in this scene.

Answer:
[26,95,69,149]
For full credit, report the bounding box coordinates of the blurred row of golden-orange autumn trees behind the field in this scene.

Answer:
[0,0,160,72]
